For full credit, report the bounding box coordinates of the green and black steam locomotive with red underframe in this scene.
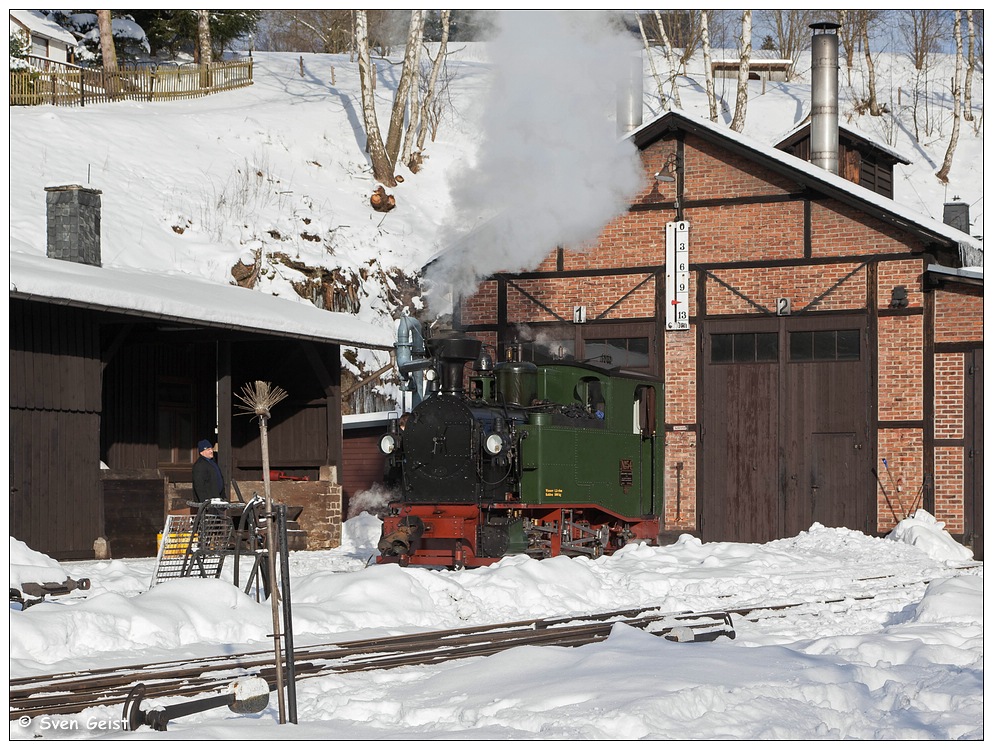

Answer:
[378,320,664,568]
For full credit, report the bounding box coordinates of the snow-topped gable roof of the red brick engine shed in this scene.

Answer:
[626,110,983,265]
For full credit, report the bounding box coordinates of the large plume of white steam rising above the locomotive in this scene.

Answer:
[426,11,643,312]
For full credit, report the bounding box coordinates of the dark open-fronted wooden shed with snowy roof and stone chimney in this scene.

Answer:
[10,186,393,559]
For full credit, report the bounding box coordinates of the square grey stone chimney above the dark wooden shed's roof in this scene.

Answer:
[45,185,101,266]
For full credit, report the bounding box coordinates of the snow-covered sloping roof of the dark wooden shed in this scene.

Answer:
[10,249,394,349]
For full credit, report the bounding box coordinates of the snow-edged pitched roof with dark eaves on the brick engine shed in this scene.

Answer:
[627,110,983,266]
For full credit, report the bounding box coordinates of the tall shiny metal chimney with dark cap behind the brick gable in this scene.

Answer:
[810,21,840,174]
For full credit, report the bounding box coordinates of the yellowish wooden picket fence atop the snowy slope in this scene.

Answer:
[10,55,252,107]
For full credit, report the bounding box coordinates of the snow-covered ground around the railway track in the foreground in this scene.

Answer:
[9,511,983,741]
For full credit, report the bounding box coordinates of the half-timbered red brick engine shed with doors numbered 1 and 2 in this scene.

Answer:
[456,112,983,556]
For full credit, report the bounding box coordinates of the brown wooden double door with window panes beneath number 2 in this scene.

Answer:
[698,316,875,542]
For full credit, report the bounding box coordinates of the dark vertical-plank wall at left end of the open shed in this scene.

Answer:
[10,300,103,558]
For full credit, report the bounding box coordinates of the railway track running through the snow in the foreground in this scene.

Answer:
[10,576,972,721]
